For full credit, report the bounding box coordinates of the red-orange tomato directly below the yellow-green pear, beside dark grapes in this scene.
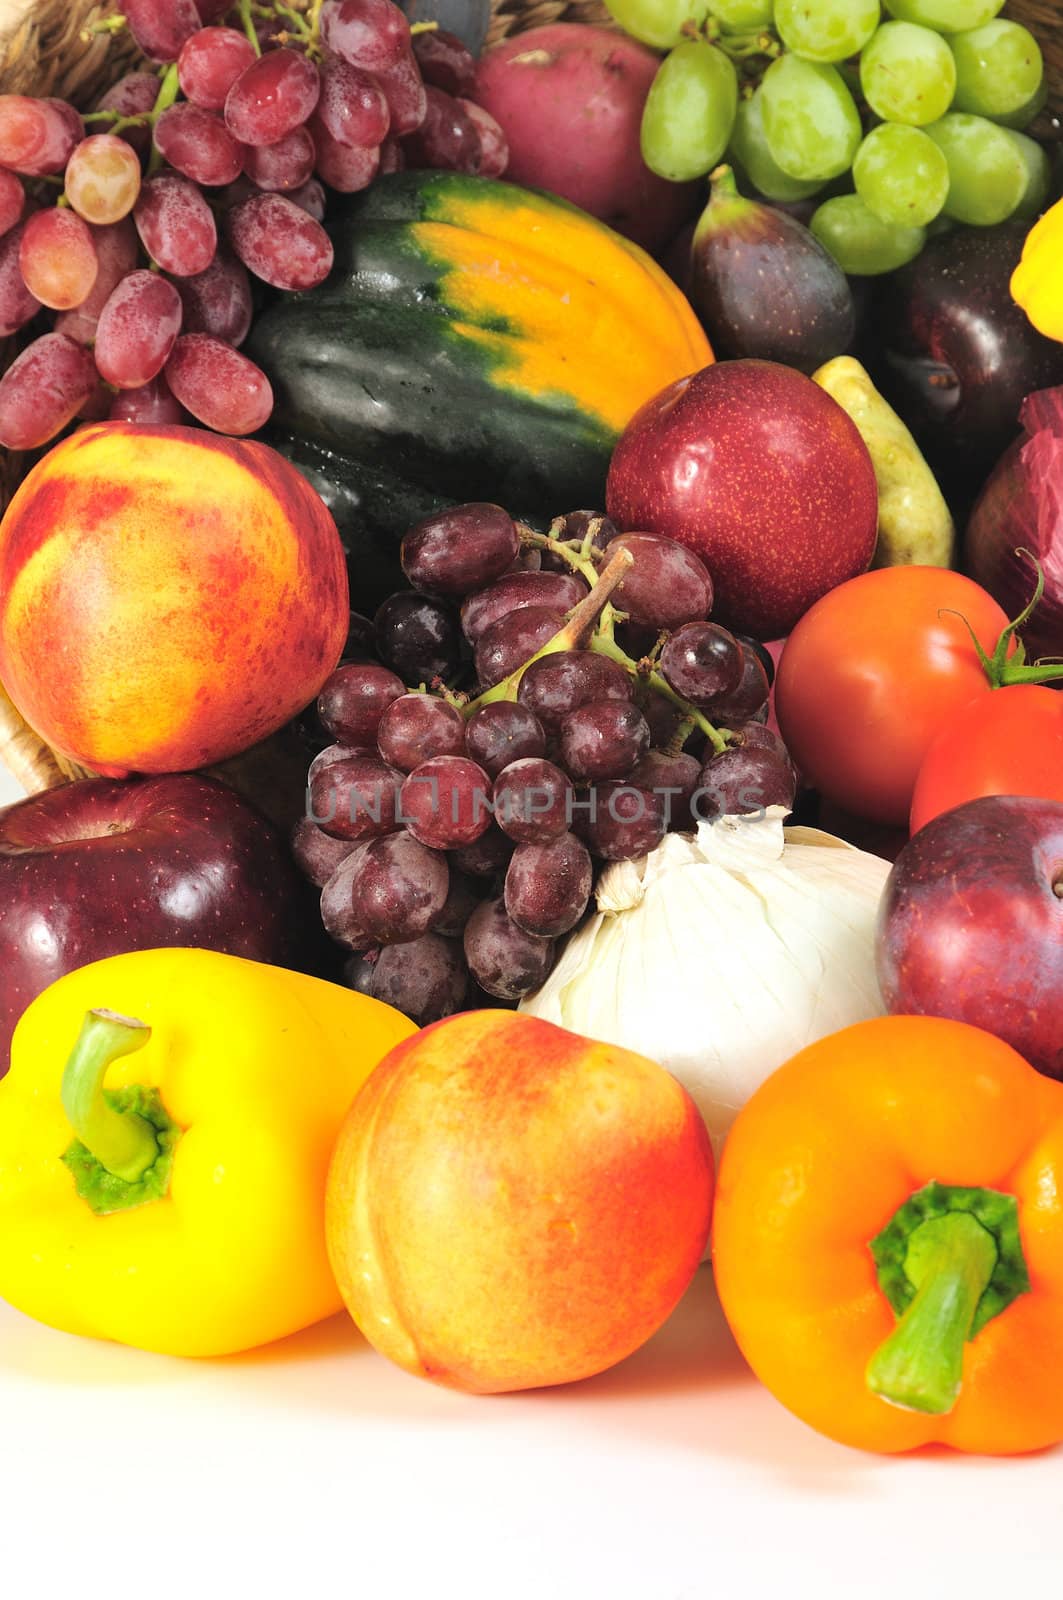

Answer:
[775,566,1009,827]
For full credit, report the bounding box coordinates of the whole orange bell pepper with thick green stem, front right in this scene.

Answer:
[714,1016,1063,1454]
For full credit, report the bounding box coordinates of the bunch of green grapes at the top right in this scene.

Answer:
[607,0,1050,275]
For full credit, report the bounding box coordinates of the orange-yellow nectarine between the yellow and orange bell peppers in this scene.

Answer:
[327,1011,712,1394]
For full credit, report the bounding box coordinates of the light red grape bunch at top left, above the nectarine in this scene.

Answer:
[0,0,509,450]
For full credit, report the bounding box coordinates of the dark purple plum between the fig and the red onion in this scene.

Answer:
[866,222,1063,496]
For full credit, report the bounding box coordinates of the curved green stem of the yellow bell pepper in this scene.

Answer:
[62,1011,158,1184]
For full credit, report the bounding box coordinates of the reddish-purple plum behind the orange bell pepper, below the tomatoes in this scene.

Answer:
[877,795,1063,1078]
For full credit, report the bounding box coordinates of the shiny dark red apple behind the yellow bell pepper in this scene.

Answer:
[0,776,322,1077]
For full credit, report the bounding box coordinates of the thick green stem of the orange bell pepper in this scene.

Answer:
[868,1211,997,1416]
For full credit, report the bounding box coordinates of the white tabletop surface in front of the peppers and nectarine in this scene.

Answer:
[0,1267,1063,1600]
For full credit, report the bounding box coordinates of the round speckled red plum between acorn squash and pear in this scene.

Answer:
[607,362,879,640]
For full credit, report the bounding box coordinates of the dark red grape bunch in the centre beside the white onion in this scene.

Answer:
[293,504,796,1022]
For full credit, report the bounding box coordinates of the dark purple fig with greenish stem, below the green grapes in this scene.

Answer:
[690,166,855,373]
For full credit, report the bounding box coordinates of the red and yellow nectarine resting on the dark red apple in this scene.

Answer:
[0,422,349,778]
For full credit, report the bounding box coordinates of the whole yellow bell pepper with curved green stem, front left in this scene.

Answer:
[0,950,416,1357]
